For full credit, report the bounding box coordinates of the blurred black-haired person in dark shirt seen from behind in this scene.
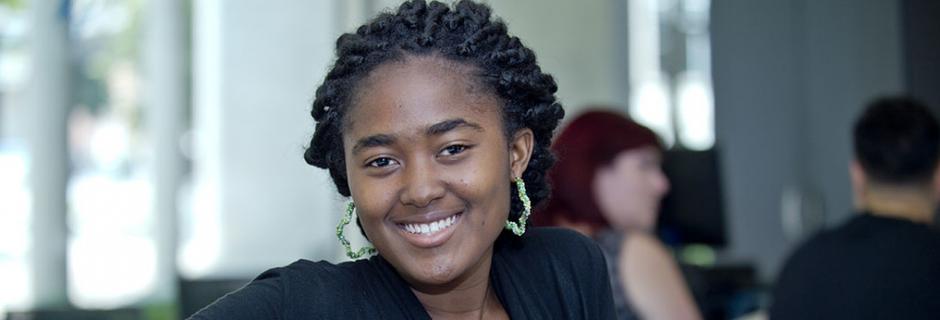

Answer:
[770,97,940,319]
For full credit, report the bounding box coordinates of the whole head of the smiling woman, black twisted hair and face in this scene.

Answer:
[304,0,564,284]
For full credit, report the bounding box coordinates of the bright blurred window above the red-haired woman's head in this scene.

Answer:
[628,0,715,150]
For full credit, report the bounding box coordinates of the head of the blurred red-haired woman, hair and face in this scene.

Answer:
[533,110,669,234]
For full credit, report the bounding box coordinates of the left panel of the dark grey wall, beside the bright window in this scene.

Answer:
[711,1,804,280]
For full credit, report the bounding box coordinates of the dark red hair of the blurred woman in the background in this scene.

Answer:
[532,110,663,227]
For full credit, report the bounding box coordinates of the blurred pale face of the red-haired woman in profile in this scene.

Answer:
[593,146,669,231]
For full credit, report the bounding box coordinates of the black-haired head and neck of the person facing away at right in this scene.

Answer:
[850,96,940,222]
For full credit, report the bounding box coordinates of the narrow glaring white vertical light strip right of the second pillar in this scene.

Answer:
[177,0,225,279]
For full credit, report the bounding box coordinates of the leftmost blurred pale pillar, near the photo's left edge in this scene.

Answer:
[26,1,71,308]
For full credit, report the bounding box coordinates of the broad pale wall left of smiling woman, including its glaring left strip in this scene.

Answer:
[193,0,342,278]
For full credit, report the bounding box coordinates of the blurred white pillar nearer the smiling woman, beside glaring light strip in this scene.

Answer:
[142,0,189,302]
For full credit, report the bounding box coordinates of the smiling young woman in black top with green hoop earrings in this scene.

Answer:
[194,1,614,319]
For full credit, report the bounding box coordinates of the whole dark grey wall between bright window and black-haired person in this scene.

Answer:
[712,0,903,279]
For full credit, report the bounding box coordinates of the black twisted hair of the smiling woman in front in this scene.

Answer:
[304,0,564,219]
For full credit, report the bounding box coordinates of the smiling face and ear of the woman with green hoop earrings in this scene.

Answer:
[343,57,533,290]
